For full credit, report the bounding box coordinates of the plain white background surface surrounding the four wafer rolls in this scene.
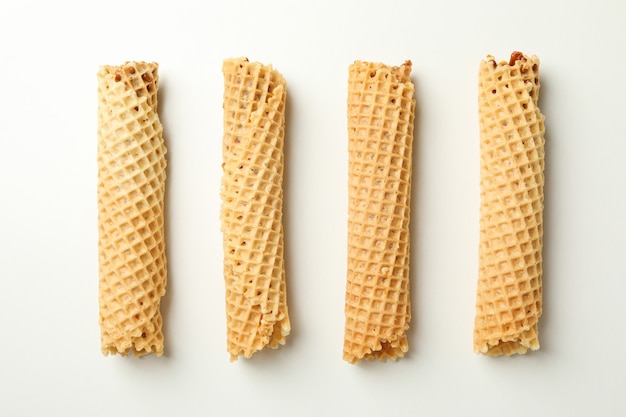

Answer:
[0,0,626,416]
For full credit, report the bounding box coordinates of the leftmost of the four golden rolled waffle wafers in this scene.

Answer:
[97,62,167,356]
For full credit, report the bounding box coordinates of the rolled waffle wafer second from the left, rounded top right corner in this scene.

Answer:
[221,58,291,361]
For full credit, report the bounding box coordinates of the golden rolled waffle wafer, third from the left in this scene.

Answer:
[343,61,415,363]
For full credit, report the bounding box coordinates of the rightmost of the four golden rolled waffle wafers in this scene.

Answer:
[474,52,544,356]
